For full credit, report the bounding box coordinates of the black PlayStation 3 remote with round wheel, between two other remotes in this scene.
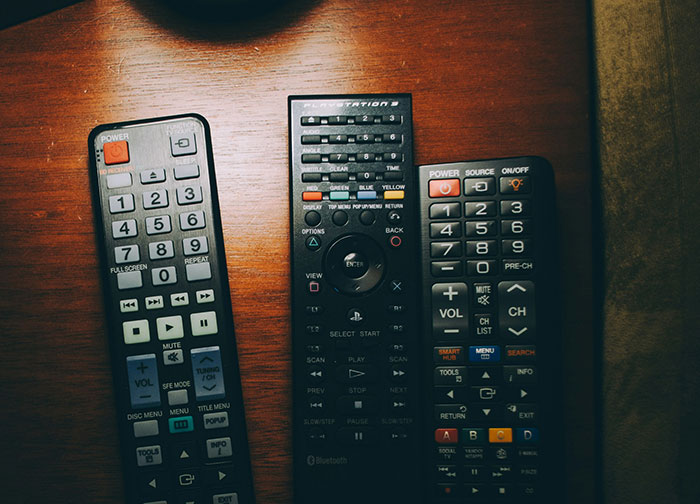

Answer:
[289,94,421,504]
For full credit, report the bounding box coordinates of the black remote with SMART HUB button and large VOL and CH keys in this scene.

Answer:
[418,157,564,503]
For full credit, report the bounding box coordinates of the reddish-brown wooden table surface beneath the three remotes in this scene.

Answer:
[0,0,596,503]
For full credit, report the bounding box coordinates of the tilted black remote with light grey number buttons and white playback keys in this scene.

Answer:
[88,114,254,504]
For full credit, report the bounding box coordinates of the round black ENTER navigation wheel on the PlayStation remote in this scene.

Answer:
[324,234,386,295]
